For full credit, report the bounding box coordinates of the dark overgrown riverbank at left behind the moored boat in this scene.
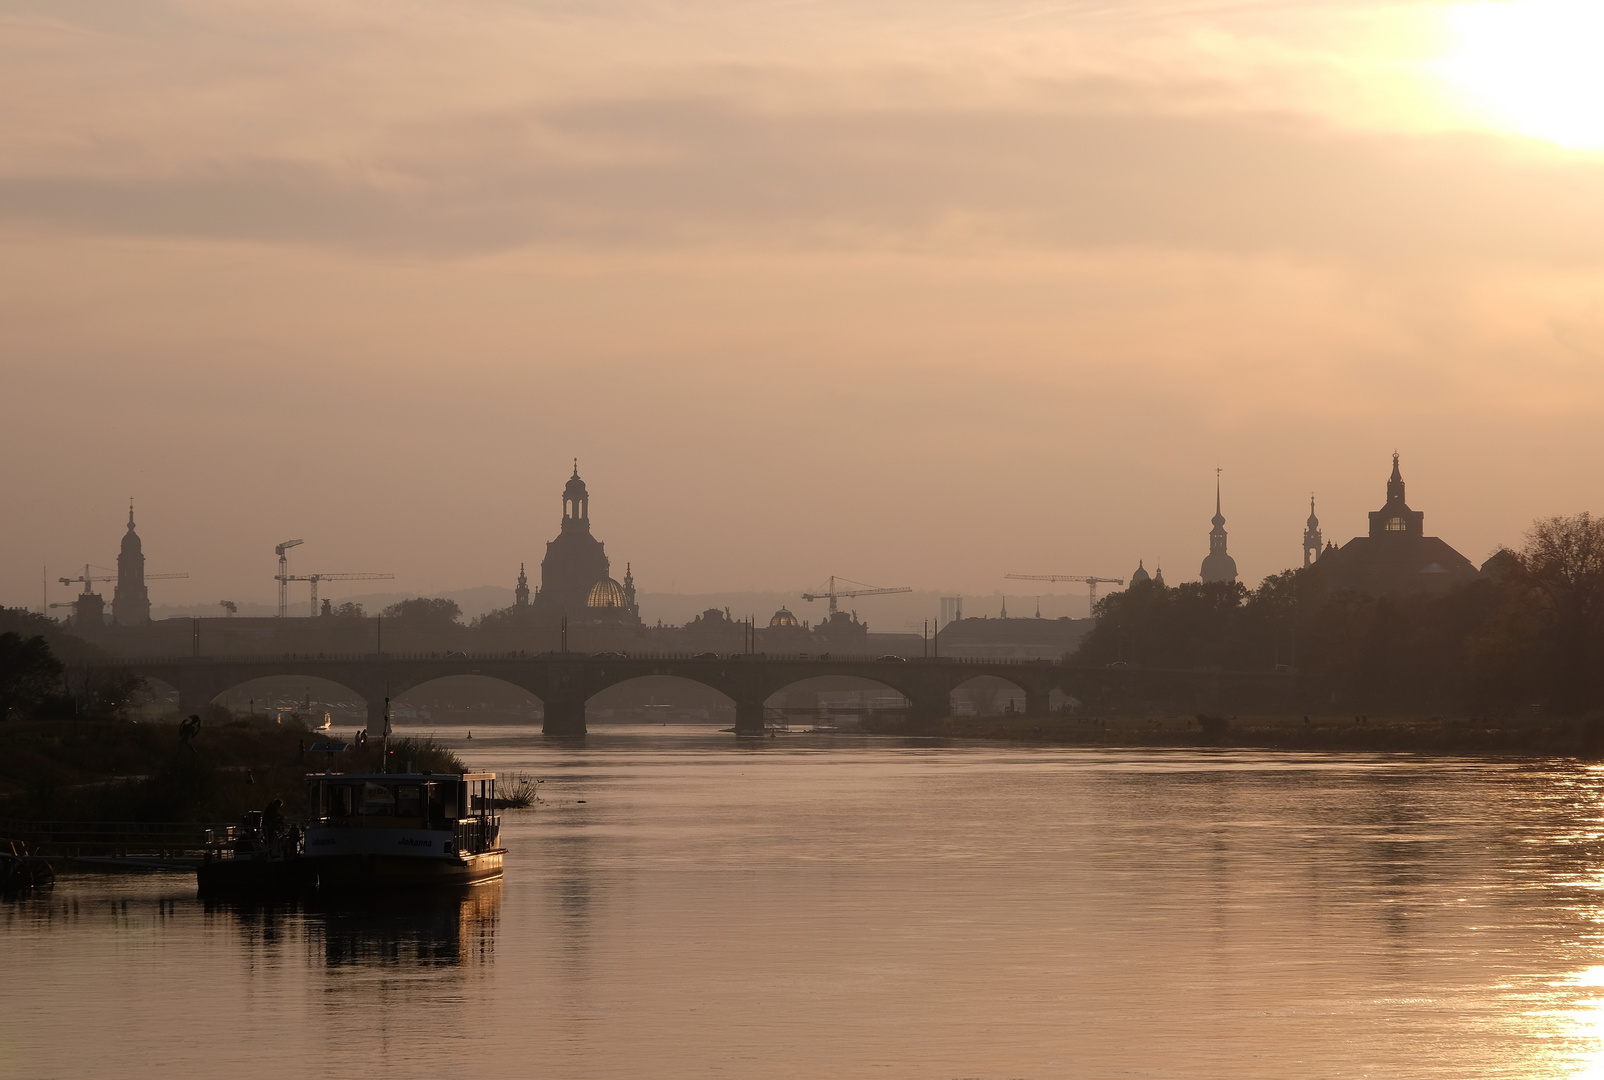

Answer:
[0,721,462,822]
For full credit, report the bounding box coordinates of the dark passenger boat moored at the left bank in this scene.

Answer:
[196,772,507,894]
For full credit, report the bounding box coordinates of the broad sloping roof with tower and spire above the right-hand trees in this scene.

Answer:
[1315,453,1477,595]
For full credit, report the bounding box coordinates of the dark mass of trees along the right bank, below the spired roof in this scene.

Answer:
[1070,514,1604,716]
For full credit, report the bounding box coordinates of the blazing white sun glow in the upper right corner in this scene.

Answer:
[1437,0,1604,149]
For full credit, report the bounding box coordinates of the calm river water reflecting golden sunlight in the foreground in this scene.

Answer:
[0,727,1604,1080]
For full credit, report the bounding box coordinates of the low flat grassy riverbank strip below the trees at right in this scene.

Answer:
[861,714,1604,759]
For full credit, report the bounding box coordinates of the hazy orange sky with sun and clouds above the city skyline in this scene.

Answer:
[0,0,1604,605]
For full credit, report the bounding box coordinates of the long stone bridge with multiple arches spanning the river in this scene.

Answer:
[125,655,1285,735]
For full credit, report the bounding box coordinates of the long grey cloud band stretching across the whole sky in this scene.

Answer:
[0,98,1604,263]
